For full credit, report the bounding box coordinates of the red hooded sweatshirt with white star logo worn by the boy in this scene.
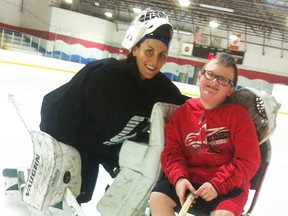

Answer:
[161,99,261,194]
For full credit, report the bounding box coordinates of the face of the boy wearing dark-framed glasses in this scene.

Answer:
[198,60,235,109]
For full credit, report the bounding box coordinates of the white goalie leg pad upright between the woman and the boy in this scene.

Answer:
[97,103,177,216]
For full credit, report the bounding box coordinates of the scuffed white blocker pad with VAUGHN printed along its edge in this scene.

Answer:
[22,131,81,210]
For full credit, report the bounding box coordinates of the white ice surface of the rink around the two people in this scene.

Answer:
[0,58,288,216]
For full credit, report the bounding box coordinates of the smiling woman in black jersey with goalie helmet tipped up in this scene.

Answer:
[40,10,186,203]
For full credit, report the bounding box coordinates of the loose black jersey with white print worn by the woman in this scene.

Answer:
[40,58,187,168]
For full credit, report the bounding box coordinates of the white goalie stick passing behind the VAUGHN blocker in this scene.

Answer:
[8,94,85,216]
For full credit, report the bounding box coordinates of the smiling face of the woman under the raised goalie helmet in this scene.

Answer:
[132,39,168,79]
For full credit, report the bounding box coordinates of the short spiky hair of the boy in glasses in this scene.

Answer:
[213,52,238,86]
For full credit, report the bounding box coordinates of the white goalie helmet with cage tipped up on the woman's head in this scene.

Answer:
[122,9,173,49]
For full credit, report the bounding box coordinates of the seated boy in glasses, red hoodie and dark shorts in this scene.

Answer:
[150,53,261,216]
